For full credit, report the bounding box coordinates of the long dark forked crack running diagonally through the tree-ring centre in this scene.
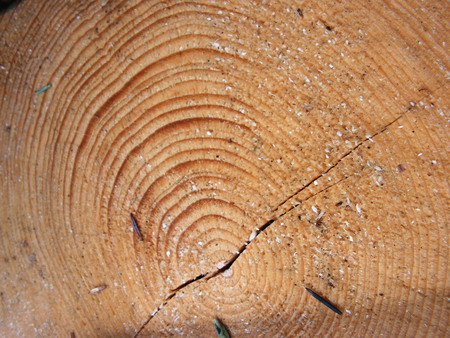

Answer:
[134,112,406,337]
